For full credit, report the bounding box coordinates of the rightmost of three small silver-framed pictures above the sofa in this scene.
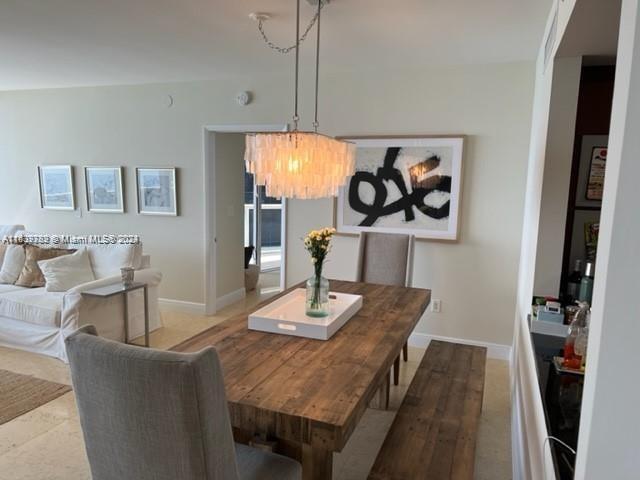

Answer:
[136,168,178,216]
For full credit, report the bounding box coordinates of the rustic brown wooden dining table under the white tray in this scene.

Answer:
[172,280,431,480]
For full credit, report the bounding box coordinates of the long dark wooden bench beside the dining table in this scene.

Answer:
[369,340,487,480]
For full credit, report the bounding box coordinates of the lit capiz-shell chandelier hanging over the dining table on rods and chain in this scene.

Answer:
[244,0,355,199]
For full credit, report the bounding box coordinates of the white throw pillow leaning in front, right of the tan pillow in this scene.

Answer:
[38,248,95,292]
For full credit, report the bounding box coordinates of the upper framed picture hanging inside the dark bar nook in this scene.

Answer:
[575,135,609,208]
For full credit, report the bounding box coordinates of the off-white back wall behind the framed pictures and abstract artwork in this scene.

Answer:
[0,63,534,345]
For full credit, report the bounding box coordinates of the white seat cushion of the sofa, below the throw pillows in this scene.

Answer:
[0,287,64,327]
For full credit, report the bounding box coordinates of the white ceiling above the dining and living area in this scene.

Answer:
[0,0,551,90]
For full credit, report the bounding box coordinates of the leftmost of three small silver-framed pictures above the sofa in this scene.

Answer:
[38,165,76,210]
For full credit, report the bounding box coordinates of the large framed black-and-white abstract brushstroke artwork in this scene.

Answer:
[335,136,464,240]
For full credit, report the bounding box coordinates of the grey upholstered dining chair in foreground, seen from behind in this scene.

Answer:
[65,326,302,480]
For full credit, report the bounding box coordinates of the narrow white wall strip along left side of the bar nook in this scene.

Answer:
[511,0,576,480]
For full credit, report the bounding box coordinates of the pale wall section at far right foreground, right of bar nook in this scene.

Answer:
[575,0,640,480]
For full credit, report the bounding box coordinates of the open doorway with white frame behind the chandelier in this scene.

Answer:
[204,125,288,315]
